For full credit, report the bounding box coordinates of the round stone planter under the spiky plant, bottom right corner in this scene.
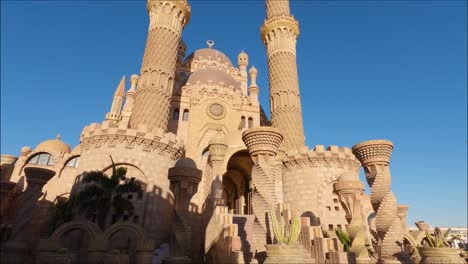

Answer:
[418,247,466,264]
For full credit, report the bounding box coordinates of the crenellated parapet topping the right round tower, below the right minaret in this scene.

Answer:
[283,145,360,173]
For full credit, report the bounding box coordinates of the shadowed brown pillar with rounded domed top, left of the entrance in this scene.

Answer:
[164,158,202,263]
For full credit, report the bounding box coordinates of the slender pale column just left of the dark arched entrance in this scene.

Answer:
[209,136,228,206]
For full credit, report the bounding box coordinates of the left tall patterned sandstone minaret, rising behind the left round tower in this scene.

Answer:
[130,0,190,131]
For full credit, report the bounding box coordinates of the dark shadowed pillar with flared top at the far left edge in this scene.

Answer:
[2,167,55,264]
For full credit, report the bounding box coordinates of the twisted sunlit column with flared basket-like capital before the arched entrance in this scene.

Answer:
[242,127,283,231]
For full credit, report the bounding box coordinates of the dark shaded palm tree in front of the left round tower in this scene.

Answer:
[77,157,143,229]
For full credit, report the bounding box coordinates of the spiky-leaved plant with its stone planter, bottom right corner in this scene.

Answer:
[418,227,466,264]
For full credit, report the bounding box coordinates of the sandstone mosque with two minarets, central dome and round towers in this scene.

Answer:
[2,0,450,263]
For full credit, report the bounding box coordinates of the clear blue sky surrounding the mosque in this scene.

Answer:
[1,1,467,226]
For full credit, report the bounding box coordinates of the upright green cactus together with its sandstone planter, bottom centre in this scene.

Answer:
[264,211,305,264]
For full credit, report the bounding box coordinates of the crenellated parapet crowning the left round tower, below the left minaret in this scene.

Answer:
[80,123,184,160]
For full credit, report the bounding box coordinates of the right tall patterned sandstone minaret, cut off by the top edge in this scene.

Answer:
[261,0,305,151]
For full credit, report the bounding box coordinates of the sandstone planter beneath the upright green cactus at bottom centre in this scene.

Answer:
[263,245,306,264]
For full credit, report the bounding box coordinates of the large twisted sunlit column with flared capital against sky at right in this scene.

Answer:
[353,140,410,263]
